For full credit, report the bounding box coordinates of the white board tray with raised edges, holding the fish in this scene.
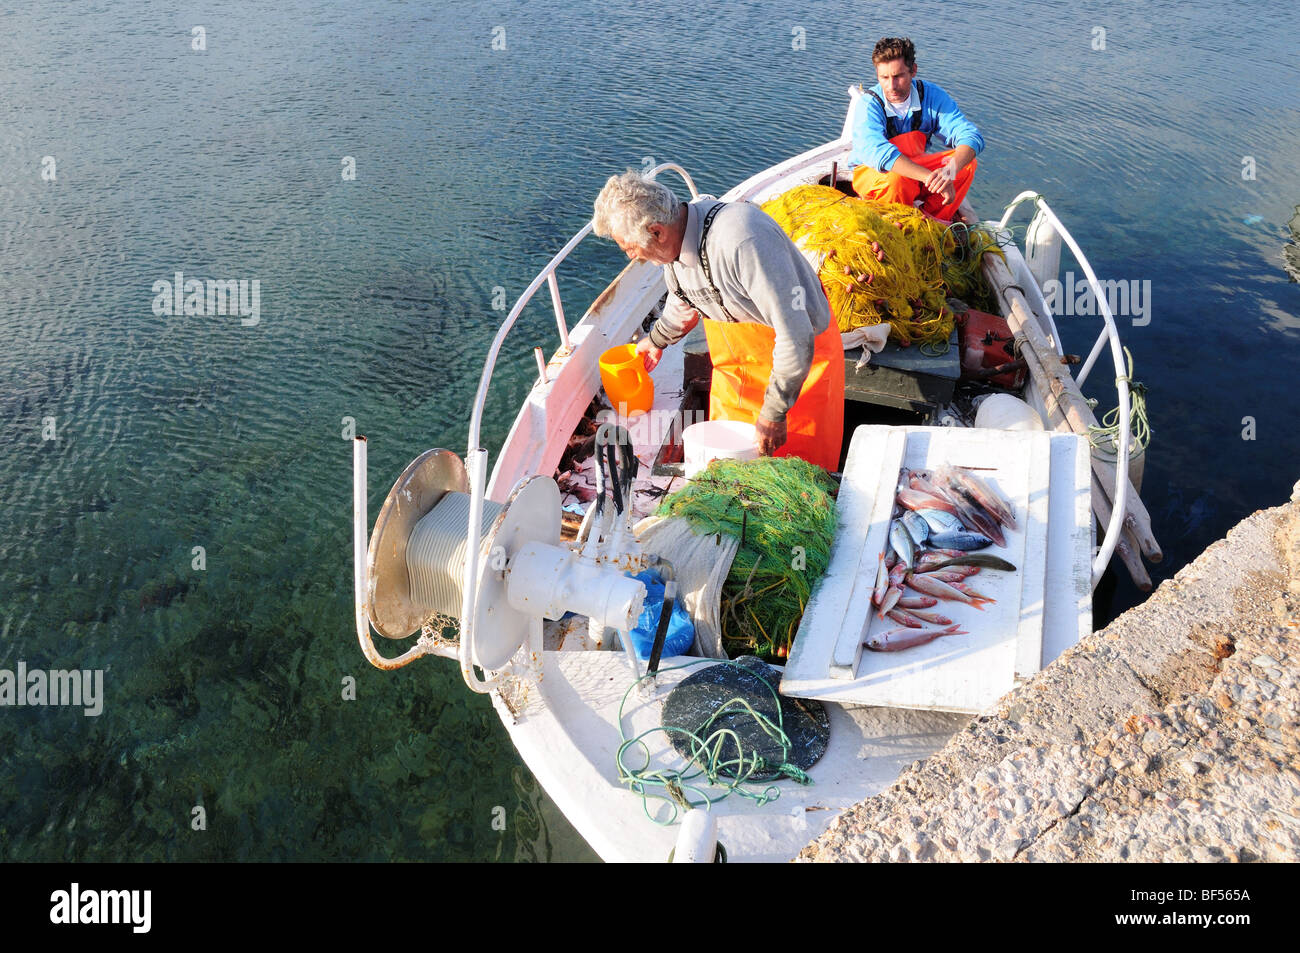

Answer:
[781,426,1092,712]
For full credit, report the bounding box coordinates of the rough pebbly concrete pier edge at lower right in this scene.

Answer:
[797,484,1300,862]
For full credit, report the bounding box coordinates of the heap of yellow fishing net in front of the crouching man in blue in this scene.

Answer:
[762,186,956,346]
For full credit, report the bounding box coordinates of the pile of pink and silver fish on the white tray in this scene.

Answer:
[863,465,1018,651]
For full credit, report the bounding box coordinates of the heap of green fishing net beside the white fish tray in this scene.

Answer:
[659,456,835,660]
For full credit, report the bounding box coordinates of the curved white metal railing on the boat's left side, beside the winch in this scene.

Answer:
[459,163,699,692]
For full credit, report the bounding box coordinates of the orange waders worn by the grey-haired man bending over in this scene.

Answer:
[701,315,844,471]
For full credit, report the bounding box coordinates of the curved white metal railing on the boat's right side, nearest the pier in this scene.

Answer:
[997,191,1130,589]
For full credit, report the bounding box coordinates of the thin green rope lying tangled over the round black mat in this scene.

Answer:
[616,659,813,826]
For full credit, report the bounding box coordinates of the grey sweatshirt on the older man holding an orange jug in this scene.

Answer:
[650,199,831,421]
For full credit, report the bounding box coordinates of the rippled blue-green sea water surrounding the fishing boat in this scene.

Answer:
[0,0,1300,861]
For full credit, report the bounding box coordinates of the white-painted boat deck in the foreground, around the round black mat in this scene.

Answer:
[493,651,970,863]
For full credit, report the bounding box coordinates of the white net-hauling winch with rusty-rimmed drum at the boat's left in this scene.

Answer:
[352,437,646,690]
